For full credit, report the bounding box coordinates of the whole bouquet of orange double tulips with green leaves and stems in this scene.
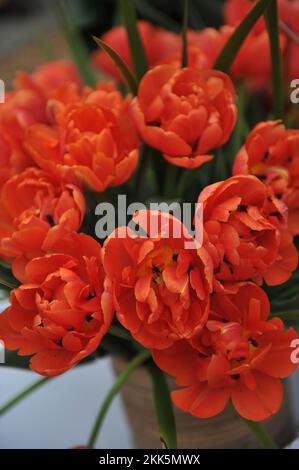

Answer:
[0,0,299,447]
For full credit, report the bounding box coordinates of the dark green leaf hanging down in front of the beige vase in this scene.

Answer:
[148,361,177,449]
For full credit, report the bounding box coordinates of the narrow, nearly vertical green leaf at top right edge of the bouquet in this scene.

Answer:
[264,0,284,119]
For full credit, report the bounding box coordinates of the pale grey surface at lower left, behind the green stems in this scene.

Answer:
[0,359,133,449]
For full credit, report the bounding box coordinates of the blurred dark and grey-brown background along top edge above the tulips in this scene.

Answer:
[0,0,223,86]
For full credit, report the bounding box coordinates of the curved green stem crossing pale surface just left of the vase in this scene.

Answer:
[87,350,151,448]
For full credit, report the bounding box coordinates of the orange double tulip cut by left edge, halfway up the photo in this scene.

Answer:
[0,168,85,281]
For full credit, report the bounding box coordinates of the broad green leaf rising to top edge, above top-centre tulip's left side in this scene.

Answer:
[120,0,148,81]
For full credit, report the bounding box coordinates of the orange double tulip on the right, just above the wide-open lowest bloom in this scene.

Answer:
[198,175,298,291]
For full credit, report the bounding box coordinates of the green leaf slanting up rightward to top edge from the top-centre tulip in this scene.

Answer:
[214,0,275,72]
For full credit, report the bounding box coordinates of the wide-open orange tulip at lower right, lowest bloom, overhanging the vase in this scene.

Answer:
[153,284,297,421]
